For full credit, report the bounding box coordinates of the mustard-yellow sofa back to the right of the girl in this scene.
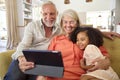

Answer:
[104,37,120,77]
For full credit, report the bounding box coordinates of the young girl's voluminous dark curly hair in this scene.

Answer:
[70,27,103,47]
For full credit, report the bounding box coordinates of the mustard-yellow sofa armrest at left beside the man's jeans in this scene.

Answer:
[0,50,15,78]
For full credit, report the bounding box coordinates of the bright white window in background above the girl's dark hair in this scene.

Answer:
[86,11,111,31]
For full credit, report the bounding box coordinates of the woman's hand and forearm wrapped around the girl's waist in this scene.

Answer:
[88,57,110,71]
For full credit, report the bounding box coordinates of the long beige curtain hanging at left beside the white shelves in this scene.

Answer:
[5,0,20,49]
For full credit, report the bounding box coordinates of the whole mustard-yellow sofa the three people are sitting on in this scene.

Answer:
[0,37,120,78]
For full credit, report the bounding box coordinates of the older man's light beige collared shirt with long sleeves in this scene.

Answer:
[12,21,61,60]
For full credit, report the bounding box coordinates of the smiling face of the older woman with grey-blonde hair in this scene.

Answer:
[62,16,77,36]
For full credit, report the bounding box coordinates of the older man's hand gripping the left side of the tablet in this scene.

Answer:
[18,56,34,72]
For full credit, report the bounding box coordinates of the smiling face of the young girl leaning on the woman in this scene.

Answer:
[76,32,89,49]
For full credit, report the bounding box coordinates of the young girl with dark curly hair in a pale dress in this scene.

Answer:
[71,27,120,80]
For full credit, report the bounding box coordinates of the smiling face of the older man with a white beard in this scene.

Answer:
[41,4,57,27]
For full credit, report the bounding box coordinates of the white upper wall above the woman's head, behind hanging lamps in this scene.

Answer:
[51,0,115,13]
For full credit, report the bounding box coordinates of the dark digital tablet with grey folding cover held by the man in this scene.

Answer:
[23,50,64,77]
